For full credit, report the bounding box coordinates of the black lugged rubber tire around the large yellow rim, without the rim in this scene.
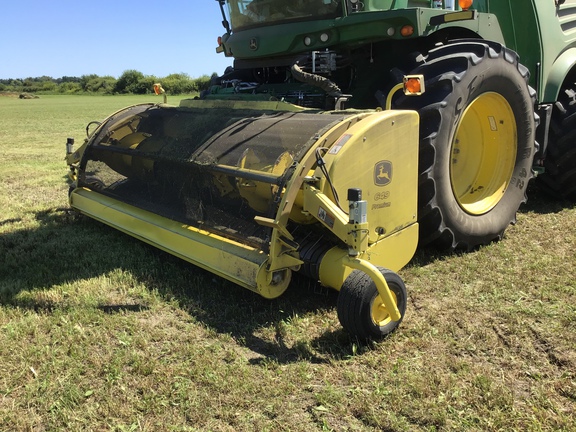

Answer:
[396,42,535,249]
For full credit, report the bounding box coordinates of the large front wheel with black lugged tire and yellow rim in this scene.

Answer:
[395,40,536,250]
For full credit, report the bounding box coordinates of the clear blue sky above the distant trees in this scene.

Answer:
[0,0,232,79]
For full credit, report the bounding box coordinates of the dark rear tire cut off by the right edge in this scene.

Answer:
[537,84,576,201]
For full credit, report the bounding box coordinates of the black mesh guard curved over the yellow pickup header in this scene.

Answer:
[79,105,345,249]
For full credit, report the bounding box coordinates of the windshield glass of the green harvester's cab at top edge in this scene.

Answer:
[226,0,341,31]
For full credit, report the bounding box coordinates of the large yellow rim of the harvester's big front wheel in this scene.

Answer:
[450,92,518,215]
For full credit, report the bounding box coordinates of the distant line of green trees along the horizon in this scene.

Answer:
[0,69,217,94]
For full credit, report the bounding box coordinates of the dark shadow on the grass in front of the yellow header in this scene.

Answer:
[0,208,354,364]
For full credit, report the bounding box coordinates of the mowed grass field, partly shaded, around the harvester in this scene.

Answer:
[0,96,576,431]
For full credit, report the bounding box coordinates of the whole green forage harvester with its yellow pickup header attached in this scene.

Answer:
[67,0,576,339]
